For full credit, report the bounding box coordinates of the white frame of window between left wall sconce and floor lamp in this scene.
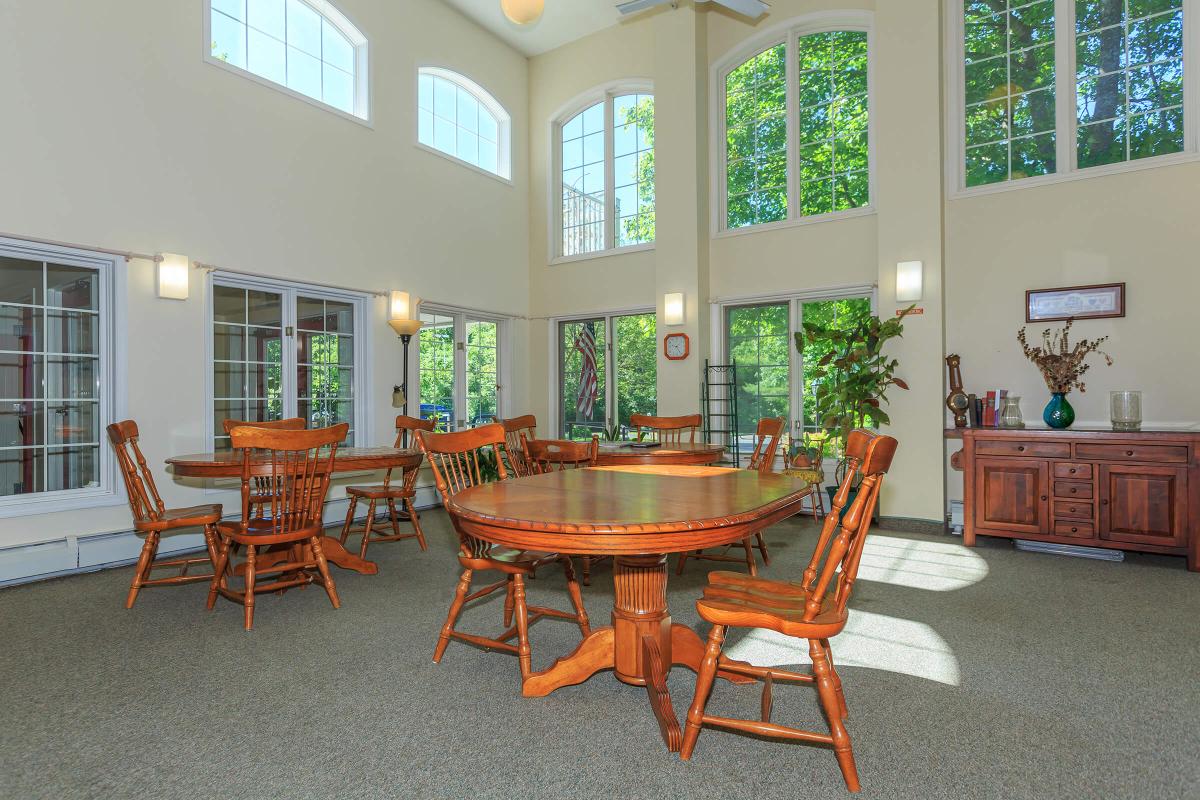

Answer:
[204,271,374,450]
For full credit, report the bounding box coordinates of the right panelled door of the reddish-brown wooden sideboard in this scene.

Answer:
[1099,464,1188,547]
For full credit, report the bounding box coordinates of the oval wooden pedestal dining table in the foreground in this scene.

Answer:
[448,465,808,751]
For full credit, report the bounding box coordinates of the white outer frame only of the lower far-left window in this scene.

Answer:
[0,237,126,518]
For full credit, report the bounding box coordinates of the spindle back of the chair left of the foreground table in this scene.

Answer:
[416,422,511,558]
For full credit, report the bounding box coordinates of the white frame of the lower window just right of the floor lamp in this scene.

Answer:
[408,302,514,431]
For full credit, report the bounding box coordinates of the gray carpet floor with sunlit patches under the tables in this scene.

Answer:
[0,511,1200,800]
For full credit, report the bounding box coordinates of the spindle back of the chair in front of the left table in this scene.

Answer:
[229,422,350,534]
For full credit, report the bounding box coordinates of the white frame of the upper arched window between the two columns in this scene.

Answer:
[709,11,876,239]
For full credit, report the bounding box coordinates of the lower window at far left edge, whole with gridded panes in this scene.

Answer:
[0,240,113,509]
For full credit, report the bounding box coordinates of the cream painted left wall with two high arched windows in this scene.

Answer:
[0,0,530,546]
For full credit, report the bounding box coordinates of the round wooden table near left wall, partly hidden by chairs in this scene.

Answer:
[167,447,424,575]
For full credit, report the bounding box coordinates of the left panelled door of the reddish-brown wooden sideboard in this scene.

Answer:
[974,457,1050,534]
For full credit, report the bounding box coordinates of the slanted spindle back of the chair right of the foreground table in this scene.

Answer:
[802,429,898,621]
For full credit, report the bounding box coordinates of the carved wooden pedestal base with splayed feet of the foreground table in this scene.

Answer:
[521,555,754,752]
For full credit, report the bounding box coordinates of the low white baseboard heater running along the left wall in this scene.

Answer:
[0,486,440,588]
